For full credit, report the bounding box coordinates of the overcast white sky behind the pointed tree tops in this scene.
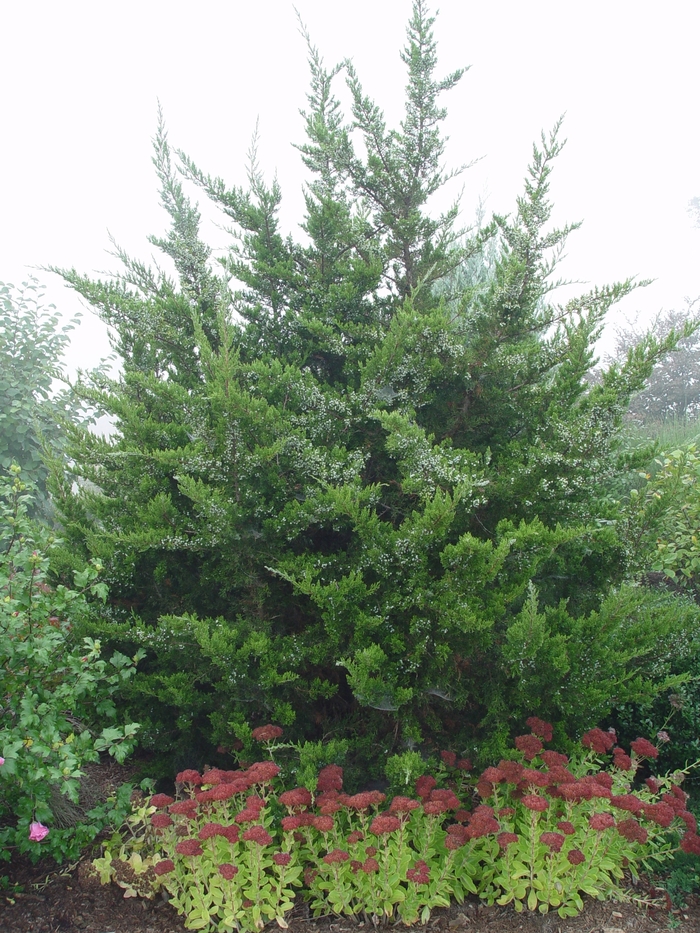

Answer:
[0,0,700,366]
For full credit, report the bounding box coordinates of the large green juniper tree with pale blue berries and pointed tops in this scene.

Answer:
[47,0,696,773]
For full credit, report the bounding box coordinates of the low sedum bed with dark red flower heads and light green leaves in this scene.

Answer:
[93,717,700,920]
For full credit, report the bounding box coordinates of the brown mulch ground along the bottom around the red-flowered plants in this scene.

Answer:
[0,858,700,933]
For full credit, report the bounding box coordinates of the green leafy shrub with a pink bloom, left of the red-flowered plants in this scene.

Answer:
[0,466,144,861]
